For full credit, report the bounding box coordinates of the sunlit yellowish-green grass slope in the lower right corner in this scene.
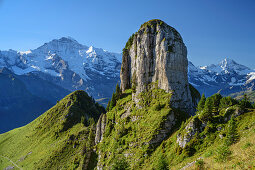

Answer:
[143,111,255,169]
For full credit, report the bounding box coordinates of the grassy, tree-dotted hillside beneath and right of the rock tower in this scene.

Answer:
[97,85,255,169]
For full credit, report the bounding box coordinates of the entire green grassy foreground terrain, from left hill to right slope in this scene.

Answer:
[0,87,255,170]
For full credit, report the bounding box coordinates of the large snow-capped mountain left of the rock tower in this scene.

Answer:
[0,37,121,104]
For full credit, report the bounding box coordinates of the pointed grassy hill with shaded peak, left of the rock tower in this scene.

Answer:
[0,91,104,169]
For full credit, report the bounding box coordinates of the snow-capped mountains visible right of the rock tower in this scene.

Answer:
[188,58,255,96]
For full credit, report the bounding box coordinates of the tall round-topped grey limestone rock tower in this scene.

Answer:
[120,20,193,111]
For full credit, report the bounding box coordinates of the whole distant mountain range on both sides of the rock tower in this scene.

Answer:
[0,37,255,133]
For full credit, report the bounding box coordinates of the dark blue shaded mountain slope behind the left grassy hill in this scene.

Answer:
[0,68,69,133]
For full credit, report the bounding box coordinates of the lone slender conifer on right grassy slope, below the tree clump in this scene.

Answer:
[225,116,238,146]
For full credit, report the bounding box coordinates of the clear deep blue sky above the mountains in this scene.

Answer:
[0,0,255,68]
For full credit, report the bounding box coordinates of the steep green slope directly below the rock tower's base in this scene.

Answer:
[97,85,189,169]
